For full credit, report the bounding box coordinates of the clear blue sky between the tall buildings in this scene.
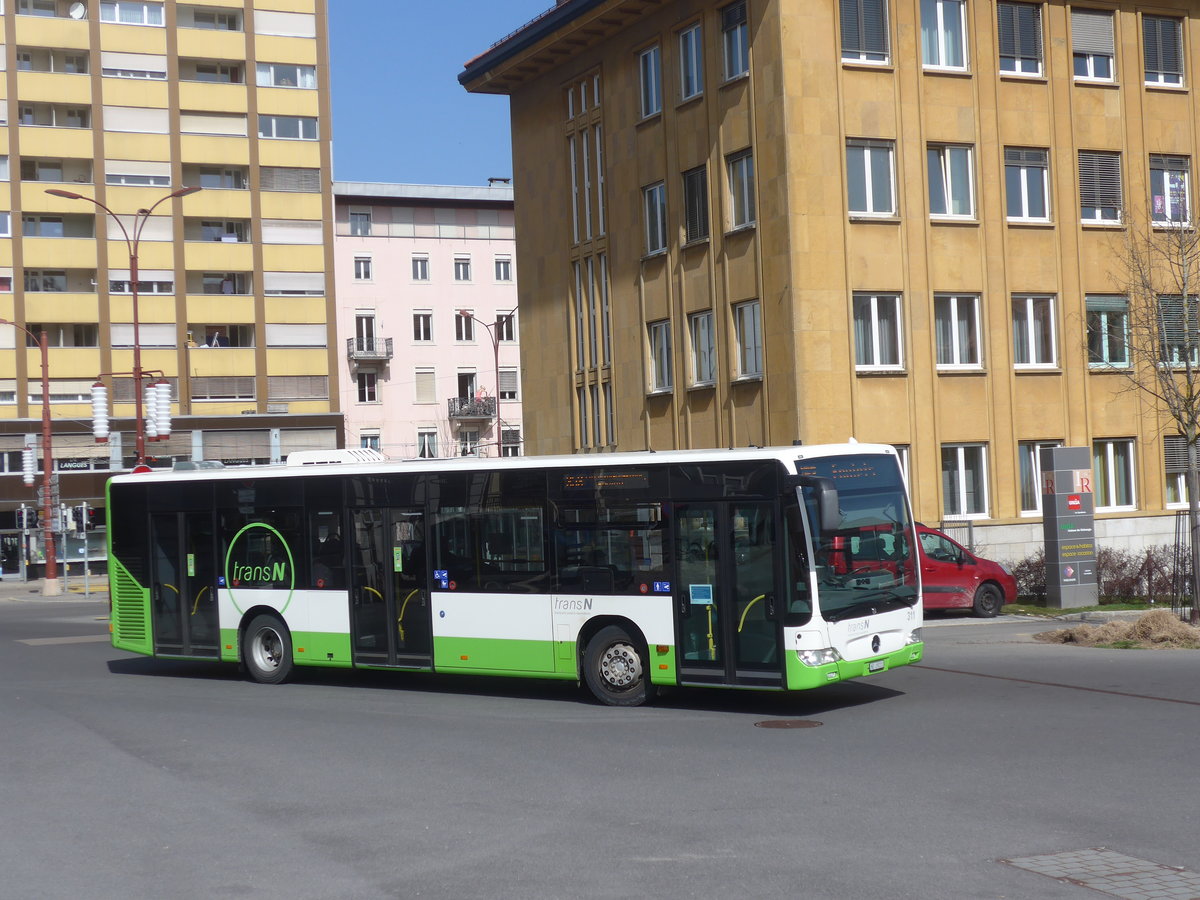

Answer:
[329,0,554,185]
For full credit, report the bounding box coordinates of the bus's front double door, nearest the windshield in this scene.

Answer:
[673,500,784,688]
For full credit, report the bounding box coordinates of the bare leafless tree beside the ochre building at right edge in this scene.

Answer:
[1108,204,1200,622]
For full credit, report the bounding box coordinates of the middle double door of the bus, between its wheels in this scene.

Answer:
[350,509,433,668]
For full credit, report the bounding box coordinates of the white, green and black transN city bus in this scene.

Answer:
[108,444,924,706]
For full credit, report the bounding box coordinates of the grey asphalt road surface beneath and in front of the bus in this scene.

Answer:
[0,598,1200,900]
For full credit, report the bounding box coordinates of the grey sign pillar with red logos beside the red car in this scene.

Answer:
[1040,446,1099,610]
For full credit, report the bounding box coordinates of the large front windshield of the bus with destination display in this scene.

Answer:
[797,454,919,622]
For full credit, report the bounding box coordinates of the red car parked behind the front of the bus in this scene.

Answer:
[917,522,1016,618]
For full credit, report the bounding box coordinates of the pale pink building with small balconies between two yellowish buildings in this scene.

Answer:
[334,181,522,457]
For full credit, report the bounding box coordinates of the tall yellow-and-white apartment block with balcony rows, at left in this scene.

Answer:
[0,0,342,564]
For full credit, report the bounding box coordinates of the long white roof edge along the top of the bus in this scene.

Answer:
[110,443,896,484]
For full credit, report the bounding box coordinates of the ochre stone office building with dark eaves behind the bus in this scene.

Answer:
[460,0,1200,558]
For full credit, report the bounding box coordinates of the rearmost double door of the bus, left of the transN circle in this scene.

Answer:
[150,512,220,659]
